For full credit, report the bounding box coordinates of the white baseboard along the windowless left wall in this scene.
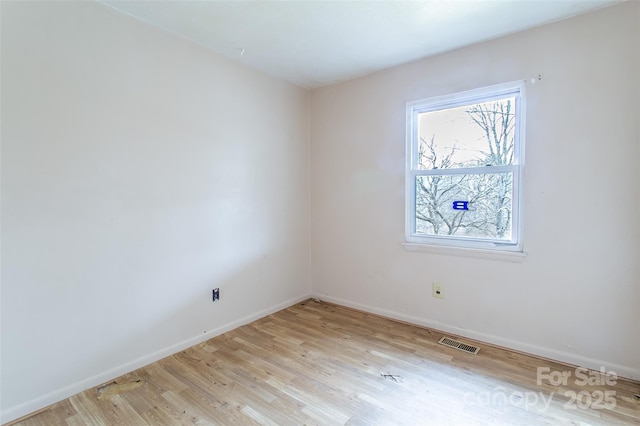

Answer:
[0,294,310,424]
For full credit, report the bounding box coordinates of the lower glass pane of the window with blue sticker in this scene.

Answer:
[416,172,513,241]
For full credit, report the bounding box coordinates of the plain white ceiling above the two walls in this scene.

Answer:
[98,0,620,88]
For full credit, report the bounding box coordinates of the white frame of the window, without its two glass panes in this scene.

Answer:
[405,81,526,253]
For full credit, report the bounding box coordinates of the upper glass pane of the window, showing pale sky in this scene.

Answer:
[418,96,516,170]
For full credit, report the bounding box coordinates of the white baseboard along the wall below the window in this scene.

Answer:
[311,294,640,381]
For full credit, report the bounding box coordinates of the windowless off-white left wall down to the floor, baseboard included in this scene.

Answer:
[1,1,309,422]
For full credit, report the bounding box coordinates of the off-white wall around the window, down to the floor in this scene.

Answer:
[311,2,640,379]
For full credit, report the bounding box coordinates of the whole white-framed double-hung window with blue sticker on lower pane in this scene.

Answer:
[405,82,524,251]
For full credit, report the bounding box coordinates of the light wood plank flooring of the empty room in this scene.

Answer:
[6,300,640,426]
